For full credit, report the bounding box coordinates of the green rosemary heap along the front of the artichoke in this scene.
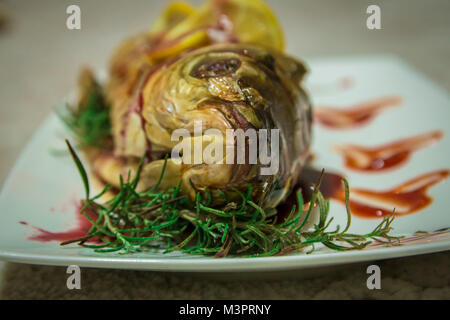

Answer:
[62,141,400,257]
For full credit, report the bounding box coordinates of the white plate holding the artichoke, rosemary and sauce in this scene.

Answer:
[0,56,450,272]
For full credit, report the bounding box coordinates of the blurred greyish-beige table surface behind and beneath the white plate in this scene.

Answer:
[0,0,450,299]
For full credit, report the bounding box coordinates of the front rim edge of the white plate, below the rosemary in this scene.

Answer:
[0,240,450,272]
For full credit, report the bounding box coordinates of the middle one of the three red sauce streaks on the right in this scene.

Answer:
[335,131,443,172]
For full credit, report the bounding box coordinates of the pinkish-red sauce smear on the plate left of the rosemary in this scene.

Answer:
[19,204,95,242]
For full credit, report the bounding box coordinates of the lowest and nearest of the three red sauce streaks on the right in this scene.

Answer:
[332,169,449,218]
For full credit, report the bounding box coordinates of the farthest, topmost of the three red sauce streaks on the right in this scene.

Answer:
[314,96,402,129]
